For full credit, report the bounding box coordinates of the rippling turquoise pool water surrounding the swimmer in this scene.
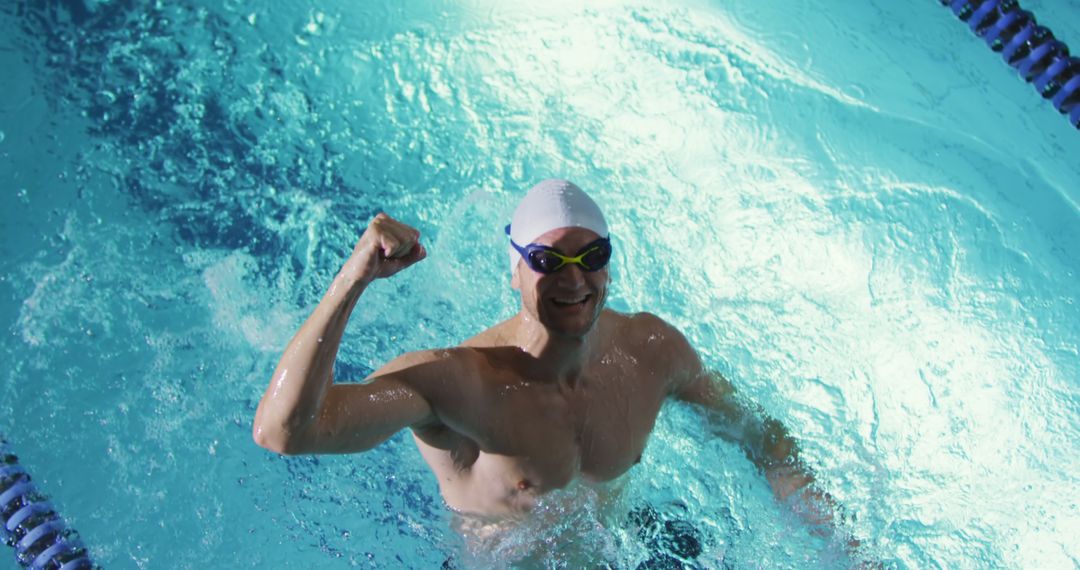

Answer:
[0,0,1080,568]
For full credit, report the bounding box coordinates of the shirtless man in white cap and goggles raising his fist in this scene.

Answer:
[254,180,828,524]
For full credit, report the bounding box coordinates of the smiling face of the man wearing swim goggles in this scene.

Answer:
[511,228,608,337]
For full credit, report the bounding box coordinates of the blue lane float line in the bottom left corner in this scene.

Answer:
[0,437,96,570]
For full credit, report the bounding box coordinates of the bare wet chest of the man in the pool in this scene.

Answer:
[413,311,671,514]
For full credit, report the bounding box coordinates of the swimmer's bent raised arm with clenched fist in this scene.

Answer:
[252,214,434,454]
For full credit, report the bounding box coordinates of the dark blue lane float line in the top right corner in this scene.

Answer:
[940,0,1080,128]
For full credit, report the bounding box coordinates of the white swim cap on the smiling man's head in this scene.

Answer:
[510,178,608,273]
